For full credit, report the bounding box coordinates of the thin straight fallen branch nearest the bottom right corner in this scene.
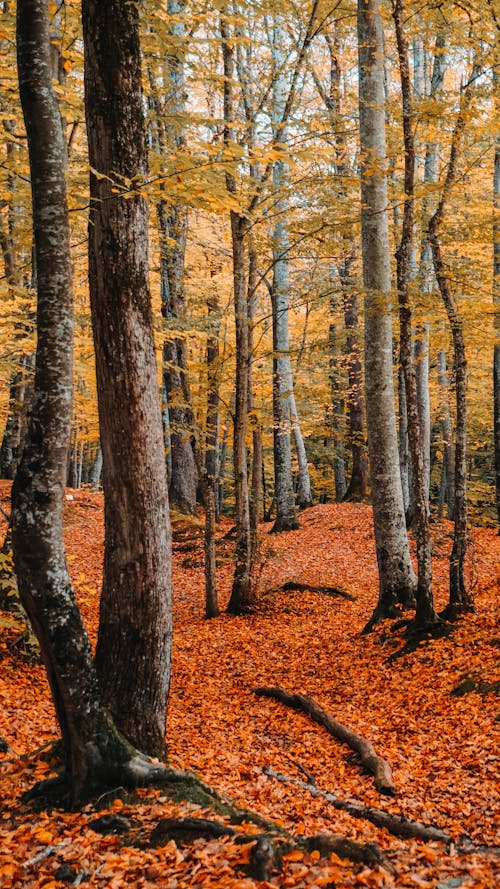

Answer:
[263,766,452,843]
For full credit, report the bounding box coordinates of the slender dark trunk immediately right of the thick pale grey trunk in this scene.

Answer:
[393,0,436,627]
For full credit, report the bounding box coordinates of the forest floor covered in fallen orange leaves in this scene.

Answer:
[0,483,500,889]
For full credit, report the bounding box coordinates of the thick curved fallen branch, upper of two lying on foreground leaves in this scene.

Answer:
[254,688,396,796]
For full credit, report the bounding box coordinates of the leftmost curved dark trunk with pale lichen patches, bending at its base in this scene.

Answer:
[12,0,164,796]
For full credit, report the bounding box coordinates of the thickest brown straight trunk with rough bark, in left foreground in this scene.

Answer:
[82,0,171,756]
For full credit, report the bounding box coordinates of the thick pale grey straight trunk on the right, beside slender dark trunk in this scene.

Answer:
[358,0,416,625]
